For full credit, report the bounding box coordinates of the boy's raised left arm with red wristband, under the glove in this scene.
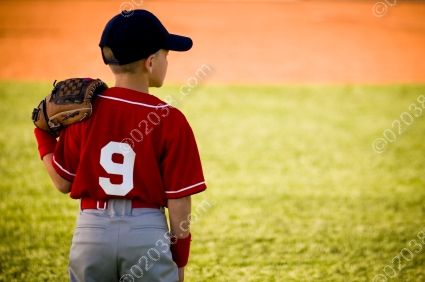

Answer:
[34,128,71,193]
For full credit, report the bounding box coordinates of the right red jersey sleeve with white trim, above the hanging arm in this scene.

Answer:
[161,110,207,199]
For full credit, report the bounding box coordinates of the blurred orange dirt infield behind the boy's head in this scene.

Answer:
[0,0,425,84]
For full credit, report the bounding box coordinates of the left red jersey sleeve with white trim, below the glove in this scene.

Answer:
[52,126,80,182]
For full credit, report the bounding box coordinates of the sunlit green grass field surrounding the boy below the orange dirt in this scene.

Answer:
[0,82,425,282]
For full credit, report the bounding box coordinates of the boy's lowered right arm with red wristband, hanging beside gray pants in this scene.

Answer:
[167,196,192,281]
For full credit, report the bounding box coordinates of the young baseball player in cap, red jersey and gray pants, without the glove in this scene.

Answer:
[35,10,206,282]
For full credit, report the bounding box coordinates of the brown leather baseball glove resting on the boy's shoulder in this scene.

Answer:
[32,78,108,136]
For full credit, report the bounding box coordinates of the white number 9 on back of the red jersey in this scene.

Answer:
[99,141,136,196]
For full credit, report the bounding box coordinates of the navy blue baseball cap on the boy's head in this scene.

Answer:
[99,10,193,65]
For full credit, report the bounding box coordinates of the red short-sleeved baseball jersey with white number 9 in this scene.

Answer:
[53,87,206,206]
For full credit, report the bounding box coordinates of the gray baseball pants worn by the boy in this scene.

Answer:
[69,199,178,282]
